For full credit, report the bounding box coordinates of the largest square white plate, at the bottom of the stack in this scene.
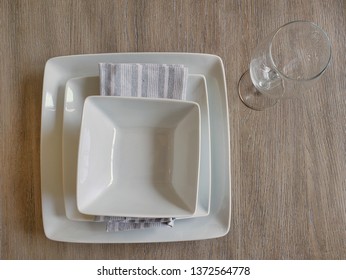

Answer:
[40,53,231,243]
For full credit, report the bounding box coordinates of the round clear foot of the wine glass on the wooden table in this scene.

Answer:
[238,70,278,111]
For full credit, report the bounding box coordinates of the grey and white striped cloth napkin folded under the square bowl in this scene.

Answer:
[95,63,188,232]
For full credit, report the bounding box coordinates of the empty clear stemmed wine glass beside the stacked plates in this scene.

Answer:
[238,21,331,110]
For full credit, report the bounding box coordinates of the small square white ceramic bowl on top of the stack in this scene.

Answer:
[77,96,201,217]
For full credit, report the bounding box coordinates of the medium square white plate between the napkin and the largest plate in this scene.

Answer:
[63,74,211,221]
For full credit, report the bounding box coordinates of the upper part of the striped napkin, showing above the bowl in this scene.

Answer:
[99,63,188,100]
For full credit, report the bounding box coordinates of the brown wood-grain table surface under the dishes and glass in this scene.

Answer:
[0,0,346,259]
